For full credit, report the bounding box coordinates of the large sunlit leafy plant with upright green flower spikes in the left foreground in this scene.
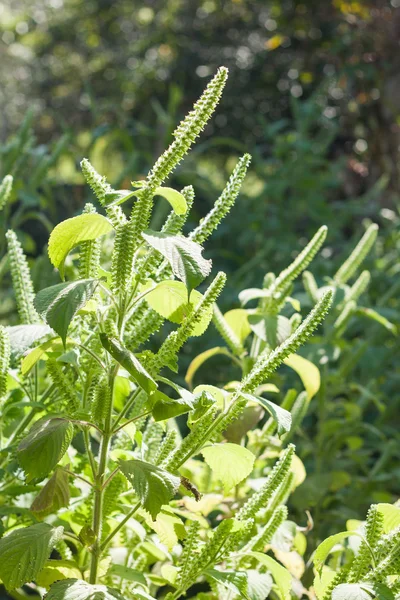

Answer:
[0,68,391,600]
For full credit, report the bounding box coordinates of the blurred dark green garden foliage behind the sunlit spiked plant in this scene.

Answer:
[0,0,400,548]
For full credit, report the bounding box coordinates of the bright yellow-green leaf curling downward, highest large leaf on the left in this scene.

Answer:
[48,213,113,279]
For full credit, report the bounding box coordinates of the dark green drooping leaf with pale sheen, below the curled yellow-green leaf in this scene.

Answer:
[34,279,99,345]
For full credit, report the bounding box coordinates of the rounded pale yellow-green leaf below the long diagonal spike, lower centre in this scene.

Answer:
[201,443,255,492]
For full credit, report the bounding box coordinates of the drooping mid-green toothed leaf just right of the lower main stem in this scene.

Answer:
[119,460,180,520]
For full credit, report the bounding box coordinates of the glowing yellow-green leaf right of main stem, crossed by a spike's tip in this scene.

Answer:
[143,280,212,336]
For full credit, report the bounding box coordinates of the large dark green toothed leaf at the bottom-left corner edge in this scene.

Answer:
[0,523,64,590]
